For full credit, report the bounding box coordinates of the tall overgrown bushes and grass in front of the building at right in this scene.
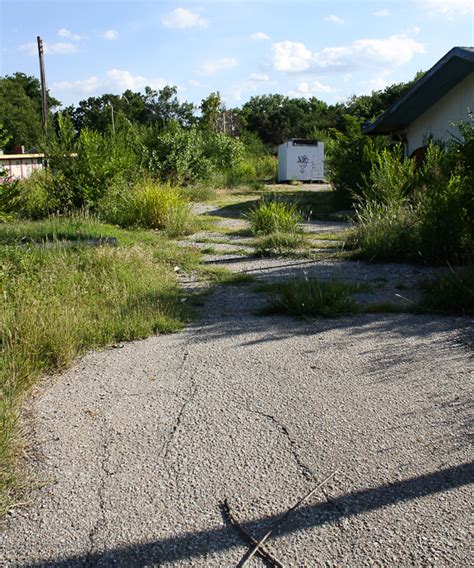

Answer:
[355,124,474,263]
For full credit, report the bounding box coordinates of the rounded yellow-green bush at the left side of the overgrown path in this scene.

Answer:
[100,179,193,237]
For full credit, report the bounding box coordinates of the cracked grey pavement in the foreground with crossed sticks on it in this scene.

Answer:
[1,278,473,567]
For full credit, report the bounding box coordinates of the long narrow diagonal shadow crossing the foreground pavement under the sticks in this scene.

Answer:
[25,462,474,568]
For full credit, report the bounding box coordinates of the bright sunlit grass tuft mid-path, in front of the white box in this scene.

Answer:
[246,199,303,235]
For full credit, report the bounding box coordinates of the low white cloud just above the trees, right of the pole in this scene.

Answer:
[51,69,170,96]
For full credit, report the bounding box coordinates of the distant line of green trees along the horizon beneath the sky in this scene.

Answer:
[0,72,421,151]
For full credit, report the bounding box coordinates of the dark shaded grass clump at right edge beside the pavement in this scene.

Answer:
[420,266,474,315]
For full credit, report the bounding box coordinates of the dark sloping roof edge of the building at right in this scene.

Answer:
[362,47,474,134]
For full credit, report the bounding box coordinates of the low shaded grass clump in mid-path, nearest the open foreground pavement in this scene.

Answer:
[265,279,358,317]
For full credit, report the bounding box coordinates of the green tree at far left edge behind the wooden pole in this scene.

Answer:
[0,73,60,151]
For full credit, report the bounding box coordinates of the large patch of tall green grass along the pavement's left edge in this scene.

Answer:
[0,217,200,516]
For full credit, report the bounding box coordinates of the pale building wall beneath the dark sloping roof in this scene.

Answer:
[406,72,474,156]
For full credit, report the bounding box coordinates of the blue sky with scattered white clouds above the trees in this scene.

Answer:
[0,0,474,108]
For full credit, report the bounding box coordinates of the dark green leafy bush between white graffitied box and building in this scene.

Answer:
[325,115,388,206]
